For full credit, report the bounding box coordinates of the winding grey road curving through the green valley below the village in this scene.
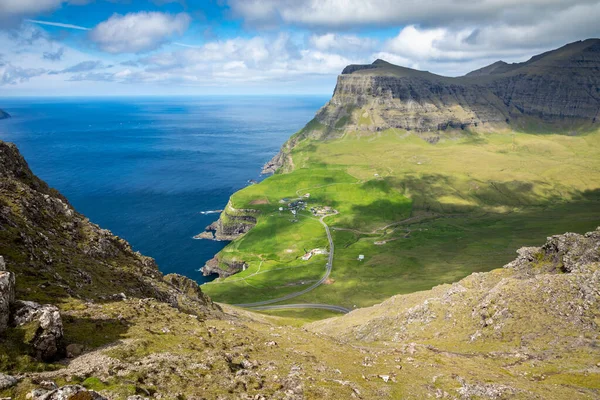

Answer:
[233,211,351,314]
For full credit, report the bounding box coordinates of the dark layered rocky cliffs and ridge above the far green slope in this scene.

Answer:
[264,39,600,173]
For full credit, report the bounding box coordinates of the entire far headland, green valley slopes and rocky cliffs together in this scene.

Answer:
[203,39,600,309]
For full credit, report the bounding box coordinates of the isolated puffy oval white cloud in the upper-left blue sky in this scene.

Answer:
[90,12,191,53]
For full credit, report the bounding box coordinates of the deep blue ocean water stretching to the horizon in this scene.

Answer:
[0,96,327,283]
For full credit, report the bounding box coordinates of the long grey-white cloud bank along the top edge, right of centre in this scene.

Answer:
[228,0,598,28]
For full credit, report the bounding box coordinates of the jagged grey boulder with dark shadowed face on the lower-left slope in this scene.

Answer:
[13,301,63,361]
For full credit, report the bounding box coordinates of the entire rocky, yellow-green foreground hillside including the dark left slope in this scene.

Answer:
[0,142,600,400]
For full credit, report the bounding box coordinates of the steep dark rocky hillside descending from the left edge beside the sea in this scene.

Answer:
[0,141,213,313]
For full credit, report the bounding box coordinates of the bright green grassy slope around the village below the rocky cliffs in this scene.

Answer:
[203,129,600,307]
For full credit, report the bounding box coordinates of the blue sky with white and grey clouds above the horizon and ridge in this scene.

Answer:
[0,0,600,97]
